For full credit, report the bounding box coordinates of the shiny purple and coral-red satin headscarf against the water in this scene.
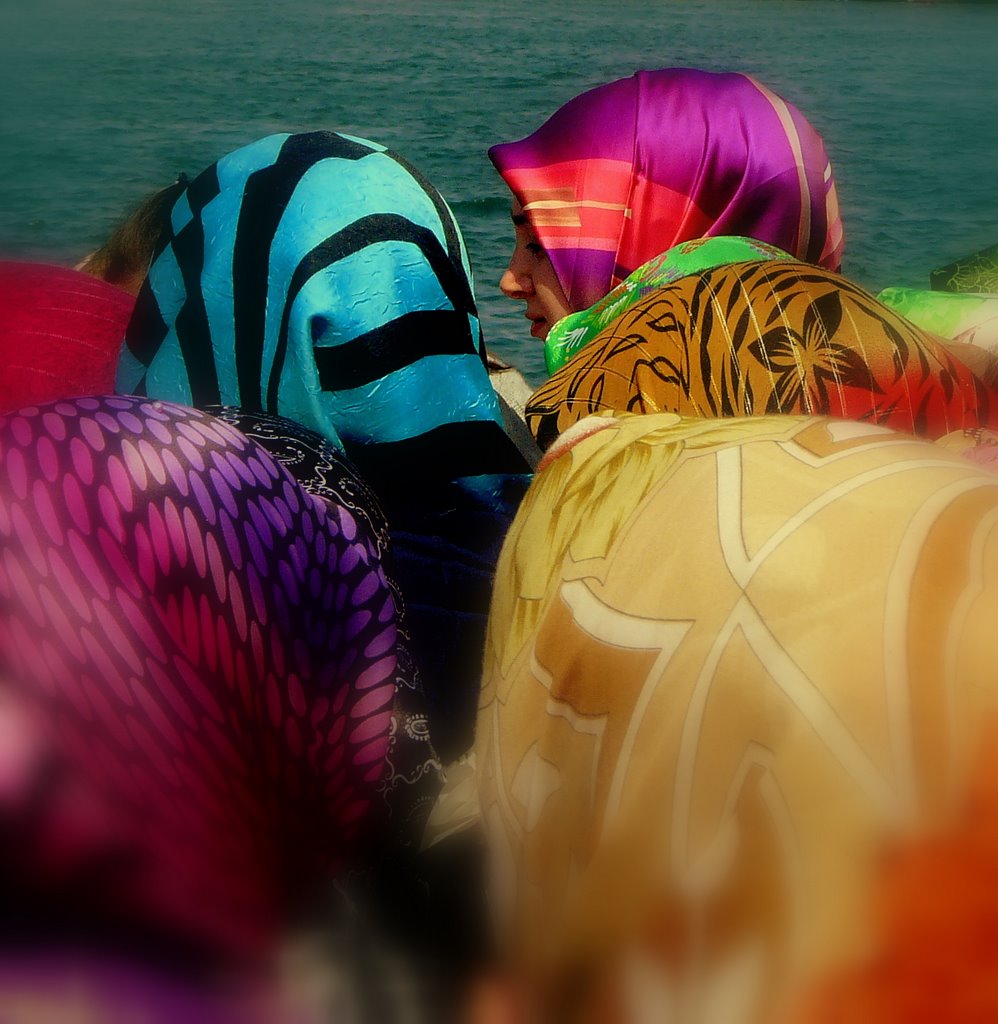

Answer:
[488,68,844,310]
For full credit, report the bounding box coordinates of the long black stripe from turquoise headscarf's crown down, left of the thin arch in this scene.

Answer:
[232,132,379,412]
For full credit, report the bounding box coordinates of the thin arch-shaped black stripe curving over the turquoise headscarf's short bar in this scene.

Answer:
[267,213,477,412]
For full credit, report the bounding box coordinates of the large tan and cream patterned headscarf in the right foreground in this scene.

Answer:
[476,415,998,1024]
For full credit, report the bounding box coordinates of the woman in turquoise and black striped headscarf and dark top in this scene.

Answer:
[118,132,529,755]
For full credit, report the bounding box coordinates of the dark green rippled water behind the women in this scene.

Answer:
[0,0,998,380]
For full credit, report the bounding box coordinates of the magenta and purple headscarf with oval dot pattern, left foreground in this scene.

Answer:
[0,396,398,957]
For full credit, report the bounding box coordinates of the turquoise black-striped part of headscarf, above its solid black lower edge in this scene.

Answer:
[118,132,519,468]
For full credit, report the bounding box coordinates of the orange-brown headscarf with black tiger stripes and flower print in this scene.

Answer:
[526,260,994,449]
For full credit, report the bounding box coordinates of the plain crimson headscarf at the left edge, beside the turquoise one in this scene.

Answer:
[0,262,135,413]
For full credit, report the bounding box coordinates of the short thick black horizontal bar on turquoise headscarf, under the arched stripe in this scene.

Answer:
[313,309,479,391]
